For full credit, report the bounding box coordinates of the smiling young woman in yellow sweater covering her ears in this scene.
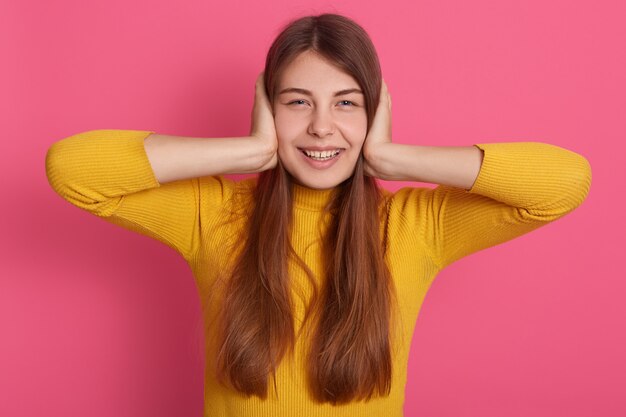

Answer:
[46,14,591,416]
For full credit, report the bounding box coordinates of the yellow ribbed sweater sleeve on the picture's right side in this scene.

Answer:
[392,142,591,269]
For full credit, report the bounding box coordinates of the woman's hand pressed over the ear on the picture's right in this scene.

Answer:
[363,80,392,180]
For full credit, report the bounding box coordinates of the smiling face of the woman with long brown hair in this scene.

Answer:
[273,51,367,189]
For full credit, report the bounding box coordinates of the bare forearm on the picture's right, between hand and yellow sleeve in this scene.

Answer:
[372,143,483,190]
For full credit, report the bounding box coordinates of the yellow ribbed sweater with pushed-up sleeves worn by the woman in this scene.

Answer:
[46,130,591,417]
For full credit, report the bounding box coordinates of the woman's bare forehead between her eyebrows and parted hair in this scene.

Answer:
[278,51,359,92]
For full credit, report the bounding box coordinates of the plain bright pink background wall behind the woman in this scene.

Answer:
[0,0,626,417]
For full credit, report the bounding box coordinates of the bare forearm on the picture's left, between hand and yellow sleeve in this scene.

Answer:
[144,133,271,183]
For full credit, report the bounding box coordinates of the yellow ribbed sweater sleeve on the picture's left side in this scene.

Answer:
[46,130,233,261]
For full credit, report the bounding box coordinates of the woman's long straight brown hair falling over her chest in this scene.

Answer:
[212,14,395,404]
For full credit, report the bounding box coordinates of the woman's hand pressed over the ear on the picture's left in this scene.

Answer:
[250,72,278,172]
